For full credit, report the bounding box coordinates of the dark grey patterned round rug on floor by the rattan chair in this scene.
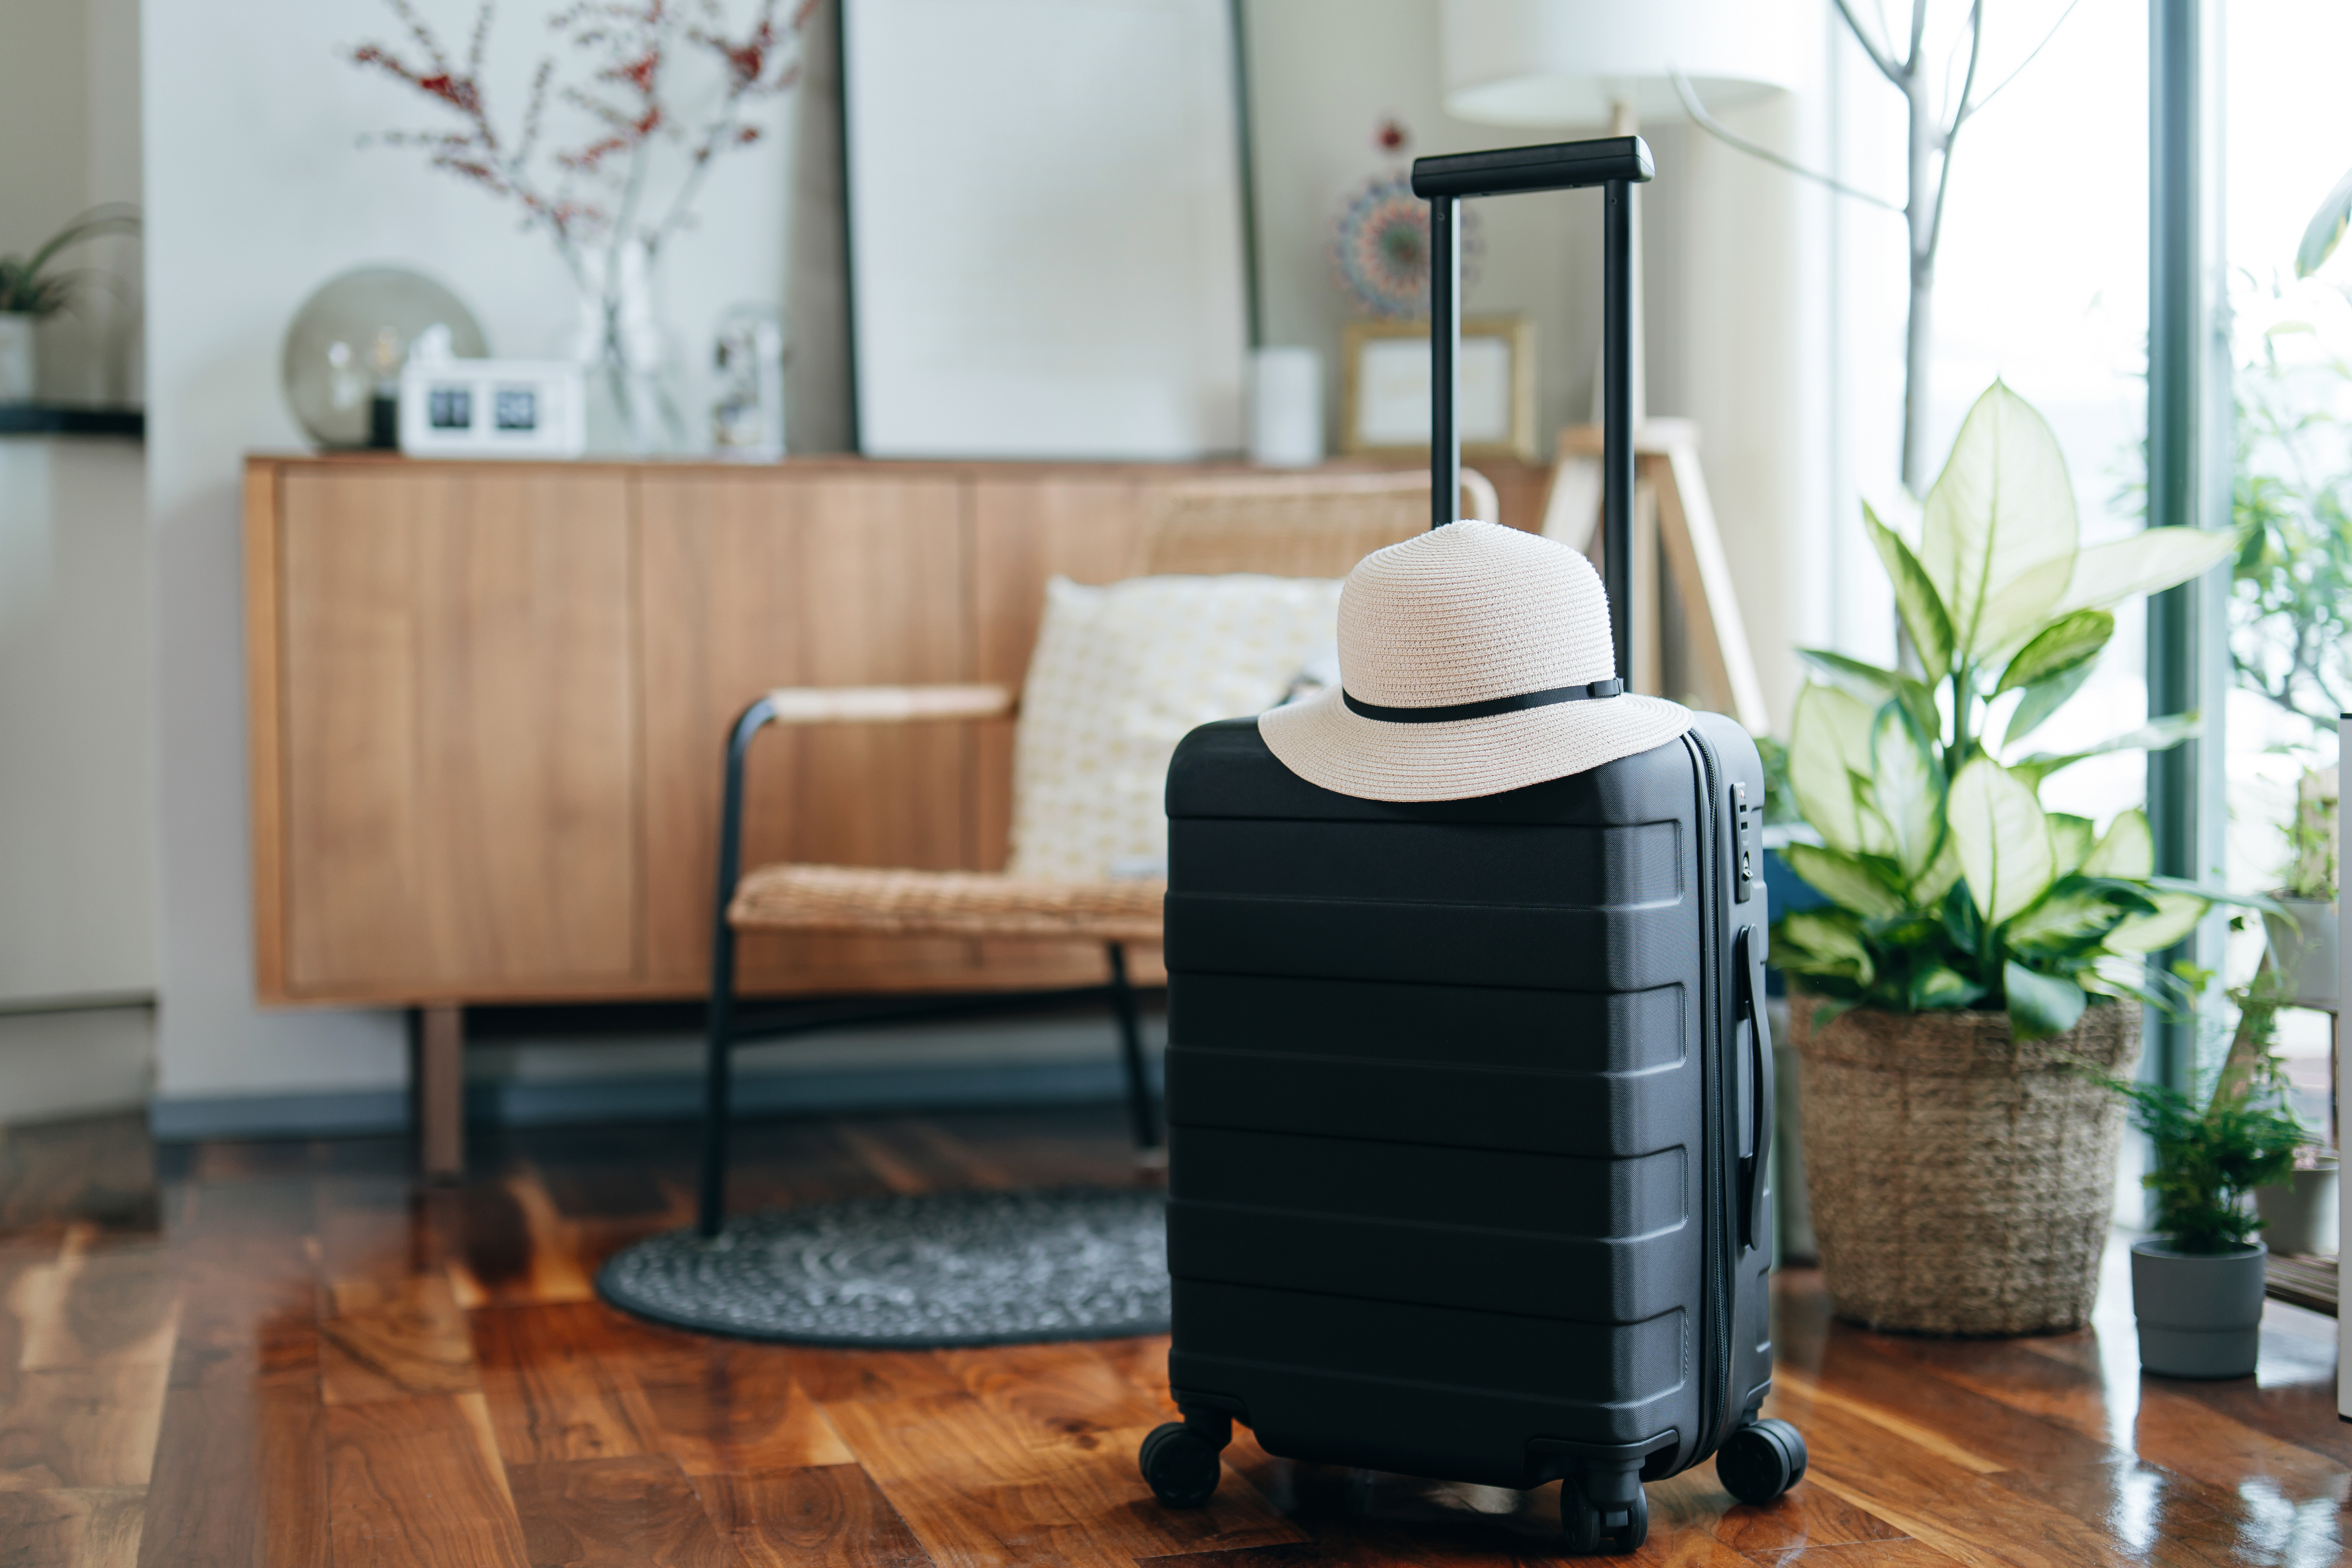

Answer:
[597,1187,1169,1349]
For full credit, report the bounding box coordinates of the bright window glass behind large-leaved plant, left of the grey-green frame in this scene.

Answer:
[1837,0,2147,823]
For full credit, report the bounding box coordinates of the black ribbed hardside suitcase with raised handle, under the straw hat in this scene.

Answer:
[1141,139,1804,1552]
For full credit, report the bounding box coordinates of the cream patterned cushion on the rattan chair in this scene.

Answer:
[1007,576,1338,881]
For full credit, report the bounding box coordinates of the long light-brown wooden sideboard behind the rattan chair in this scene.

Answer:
[245,456,1545,1006]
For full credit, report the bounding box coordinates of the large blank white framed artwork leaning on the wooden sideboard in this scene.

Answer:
[842,0,1249,461]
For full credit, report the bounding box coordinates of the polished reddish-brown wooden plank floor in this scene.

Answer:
[0,1109,2352,1568]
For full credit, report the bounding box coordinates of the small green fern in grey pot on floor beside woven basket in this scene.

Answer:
[2100,1034,2310,1378]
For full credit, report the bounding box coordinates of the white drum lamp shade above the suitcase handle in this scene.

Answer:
[1444,0,1804,127]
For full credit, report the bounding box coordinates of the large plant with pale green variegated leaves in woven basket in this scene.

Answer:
[1773,383,2232,1333]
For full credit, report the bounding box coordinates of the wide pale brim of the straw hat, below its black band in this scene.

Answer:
[1258,687,1691,801]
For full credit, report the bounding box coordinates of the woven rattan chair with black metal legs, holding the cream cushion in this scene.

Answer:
[696,473,1496,1236]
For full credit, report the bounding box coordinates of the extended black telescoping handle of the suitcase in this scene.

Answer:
[1414,136,1658,677]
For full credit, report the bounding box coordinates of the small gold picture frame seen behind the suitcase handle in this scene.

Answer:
[1338,315,1536,463]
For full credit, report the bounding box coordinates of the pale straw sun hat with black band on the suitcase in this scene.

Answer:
[1258,522,1691,799]
